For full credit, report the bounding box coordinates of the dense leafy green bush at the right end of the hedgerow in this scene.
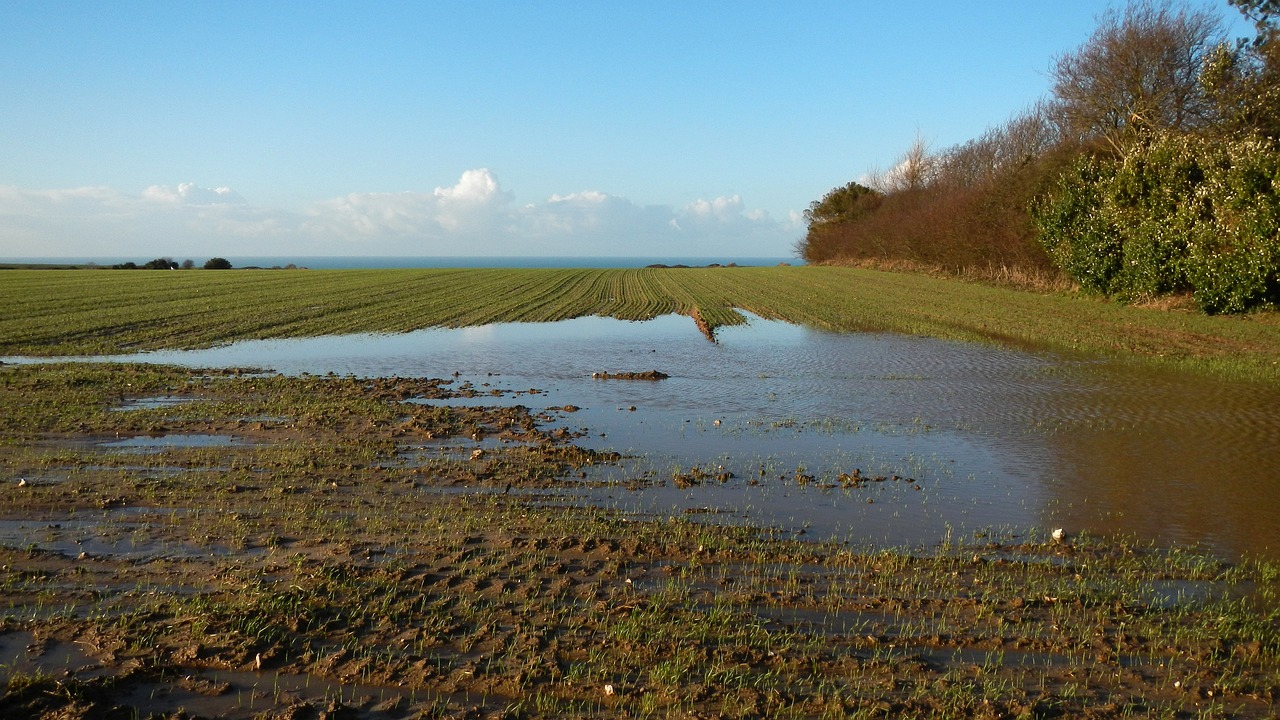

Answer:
[1032,135,1280,313]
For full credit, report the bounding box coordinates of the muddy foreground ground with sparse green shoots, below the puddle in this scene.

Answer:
[0,364,1280,720]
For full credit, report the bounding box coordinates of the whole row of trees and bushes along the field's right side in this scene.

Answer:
[797,0,1280,313]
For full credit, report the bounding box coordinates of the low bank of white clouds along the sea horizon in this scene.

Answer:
[0,168,804,259]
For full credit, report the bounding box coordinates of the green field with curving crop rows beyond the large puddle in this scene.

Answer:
[0,266,1280,382]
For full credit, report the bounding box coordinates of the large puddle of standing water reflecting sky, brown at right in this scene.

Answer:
[5,316,1280,557]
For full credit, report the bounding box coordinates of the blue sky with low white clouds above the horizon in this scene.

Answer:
[0,0,1248,259]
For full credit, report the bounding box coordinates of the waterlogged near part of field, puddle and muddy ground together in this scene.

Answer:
[0,325,1280,720]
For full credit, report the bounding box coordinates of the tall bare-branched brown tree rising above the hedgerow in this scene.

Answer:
[1052,0,1225,152]
